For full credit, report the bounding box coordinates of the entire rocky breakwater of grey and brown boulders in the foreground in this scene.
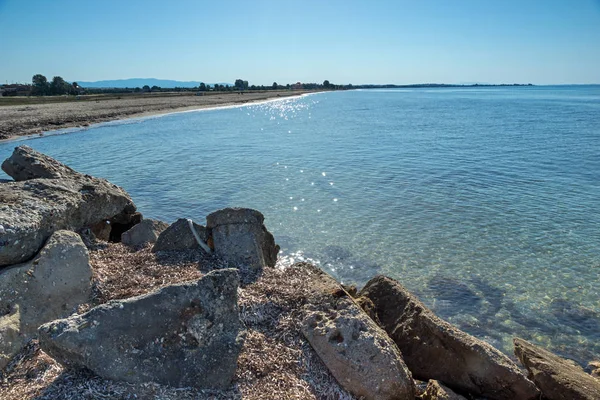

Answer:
[0,146,600,400]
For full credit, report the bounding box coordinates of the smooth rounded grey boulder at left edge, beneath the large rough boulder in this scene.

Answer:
[0,231,92,369]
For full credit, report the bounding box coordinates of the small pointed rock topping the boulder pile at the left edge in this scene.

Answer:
[2,146,80,181]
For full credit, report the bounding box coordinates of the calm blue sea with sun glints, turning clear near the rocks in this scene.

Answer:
[0,86,600,363]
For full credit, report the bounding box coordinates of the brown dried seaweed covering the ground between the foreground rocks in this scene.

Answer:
[0,243,354,400]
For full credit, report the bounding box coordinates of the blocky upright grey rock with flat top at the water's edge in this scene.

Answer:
[206,208,279,274]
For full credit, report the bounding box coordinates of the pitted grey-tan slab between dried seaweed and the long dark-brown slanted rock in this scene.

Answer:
[302,266,415,400]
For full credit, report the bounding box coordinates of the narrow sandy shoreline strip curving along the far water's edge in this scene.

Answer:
[0,90,322,143]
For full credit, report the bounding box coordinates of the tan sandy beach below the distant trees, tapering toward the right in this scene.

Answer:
[0,90,311,140]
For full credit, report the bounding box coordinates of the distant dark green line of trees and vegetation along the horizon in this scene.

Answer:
[2,74,532,96]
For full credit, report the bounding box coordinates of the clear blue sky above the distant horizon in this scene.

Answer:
[0,0,600,84]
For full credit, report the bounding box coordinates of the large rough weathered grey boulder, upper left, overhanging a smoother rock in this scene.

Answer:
[0,146,135,267]
